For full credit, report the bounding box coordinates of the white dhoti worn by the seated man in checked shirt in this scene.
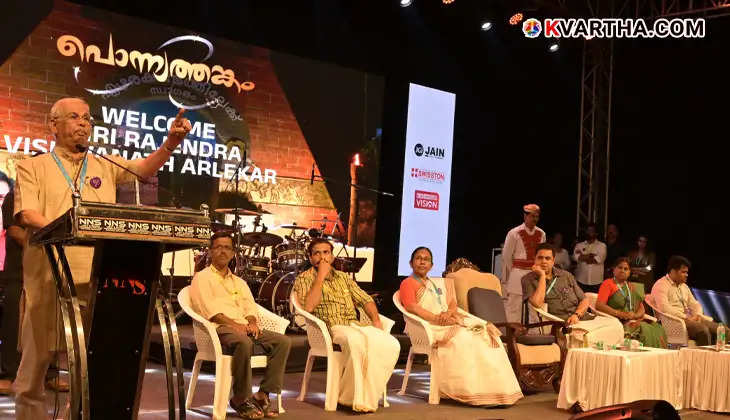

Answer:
[331,325,400,412]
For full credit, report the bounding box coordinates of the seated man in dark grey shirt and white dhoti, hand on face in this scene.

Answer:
[522,244,624,345]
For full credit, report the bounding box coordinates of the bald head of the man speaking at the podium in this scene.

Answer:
[49,98,91,151]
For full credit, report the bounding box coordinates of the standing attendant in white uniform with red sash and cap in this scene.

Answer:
[501,204,545,322]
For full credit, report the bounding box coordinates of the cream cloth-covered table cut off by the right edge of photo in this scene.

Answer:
[679,346,730,413]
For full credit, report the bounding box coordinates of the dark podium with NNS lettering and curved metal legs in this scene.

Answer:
[31,202,210,420]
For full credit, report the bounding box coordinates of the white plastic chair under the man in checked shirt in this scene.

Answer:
[290,292,395,411]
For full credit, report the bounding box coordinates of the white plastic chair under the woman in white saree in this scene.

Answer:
[393,291,484,404]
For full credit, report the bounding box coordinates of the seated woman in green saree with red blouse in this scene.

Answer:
[596,257,667,348]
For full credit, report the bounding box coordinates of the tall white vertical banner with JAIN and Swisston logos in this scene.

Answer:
[398,83,456,277]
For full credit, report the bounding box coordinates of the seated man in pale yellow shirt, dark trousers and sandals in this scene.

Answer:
[190,232,291,419]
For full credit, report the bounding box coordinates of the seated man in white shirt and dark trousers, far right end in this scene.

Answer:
[651,255,718,346]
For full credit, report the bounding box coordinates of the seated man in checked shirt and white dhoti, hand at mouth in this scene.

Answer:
[294,238,400,412]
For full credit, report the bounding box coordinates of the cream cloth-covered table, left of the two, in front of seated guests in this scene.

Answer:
[558,347,683,410]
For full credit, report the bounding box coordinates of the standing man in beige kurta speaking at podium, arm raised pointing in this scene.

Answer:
[13,98,192,420]
